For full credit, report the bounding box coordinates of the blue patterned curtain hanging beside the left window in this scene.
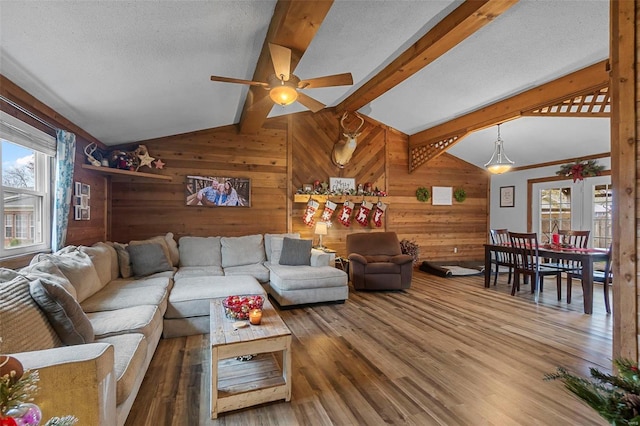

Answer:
[51,129,76,252]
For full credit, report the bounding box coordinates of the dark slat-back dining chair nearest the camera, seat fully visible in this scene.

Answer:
[509,232,562,301]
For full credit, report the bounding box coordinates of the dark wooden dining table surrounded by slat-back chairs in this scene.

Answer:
[484,244,607,314]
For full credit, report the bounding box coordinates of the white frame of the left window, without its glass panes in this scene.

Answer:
[0,111,56,259]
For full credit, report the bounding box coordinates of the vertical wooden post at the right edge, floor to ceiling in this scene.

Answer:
[610,0,640,361]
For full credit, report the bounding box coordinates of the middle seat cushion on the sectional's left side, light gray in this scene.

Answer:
[87,305,162,339]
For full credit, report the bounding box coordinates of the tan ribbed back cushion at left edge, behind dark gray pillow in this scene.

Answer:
[0,277,62,354]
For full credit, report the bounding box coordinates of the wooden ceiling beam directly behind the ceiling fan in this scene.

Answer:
[239,0,333,133]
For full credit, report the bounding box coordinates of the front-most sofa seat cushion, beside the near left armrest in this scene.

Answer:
[98,333,149,404]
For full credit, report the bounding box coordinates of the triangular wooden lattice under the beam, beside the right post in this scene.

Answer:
[522,86,611,117]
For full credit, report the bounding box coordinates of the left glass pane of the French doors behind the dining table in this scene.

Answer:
[540,187,572,244]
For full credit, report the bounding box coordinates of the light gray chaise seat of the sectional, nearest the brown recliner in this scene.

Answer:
[267,264,349,306]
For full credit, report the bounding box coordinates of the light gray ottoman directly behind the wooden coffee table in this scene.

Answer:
[162,275,267,339]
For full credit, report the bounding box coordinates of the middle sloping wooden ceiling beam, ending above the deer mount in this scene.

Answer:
[336,0,518,114]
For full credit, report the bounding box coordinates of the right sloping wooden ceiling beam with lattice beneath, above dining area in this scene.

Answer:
[409,60,609,172]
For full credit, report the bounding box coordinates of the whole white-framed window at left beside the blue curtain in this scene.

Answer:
[0,113,55,257]
